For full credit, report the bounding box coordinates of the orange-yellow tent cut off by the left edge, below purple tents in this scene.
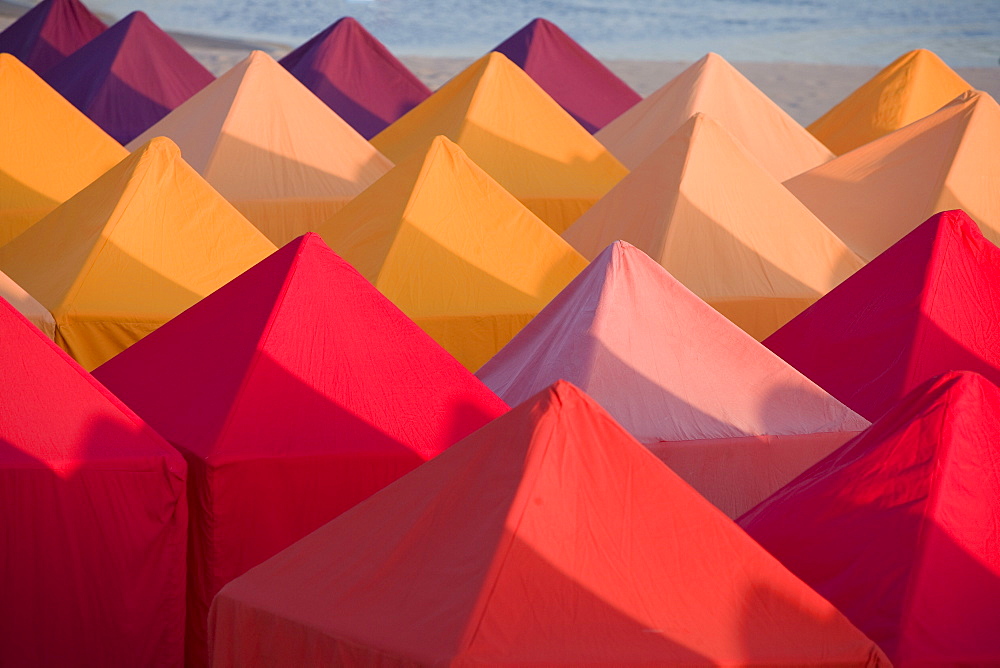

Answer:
[0,53,128,245]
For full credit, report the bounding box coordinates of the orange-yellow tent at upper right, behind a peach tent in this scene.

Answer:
[808,49,972,155]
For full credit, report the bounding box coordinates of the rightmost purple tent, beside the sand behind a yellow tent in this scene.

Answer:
[493,19,642,132]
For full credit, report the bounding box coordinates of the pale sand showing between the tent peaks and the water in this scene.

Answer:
[0,0,1000,125]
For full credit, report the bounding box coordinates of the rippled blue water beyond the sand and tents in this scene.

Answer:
[88,0,1000,67]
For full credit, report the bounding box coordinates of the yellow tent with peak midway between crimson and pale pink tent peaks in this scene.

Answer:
[317,137,587,370]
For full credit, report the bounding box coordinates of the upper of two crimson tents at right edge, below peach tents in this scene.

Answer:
[764,211,1000,420]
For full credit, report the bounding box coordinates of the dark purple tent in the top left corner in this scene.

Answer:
[0,0,107,74]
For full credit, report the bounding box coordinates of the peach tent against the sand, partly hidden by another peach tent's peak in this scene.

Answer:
[595,53,833,181]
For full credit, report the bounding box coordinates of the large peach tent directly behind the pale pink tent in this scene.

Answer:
[563,114,862,340]
